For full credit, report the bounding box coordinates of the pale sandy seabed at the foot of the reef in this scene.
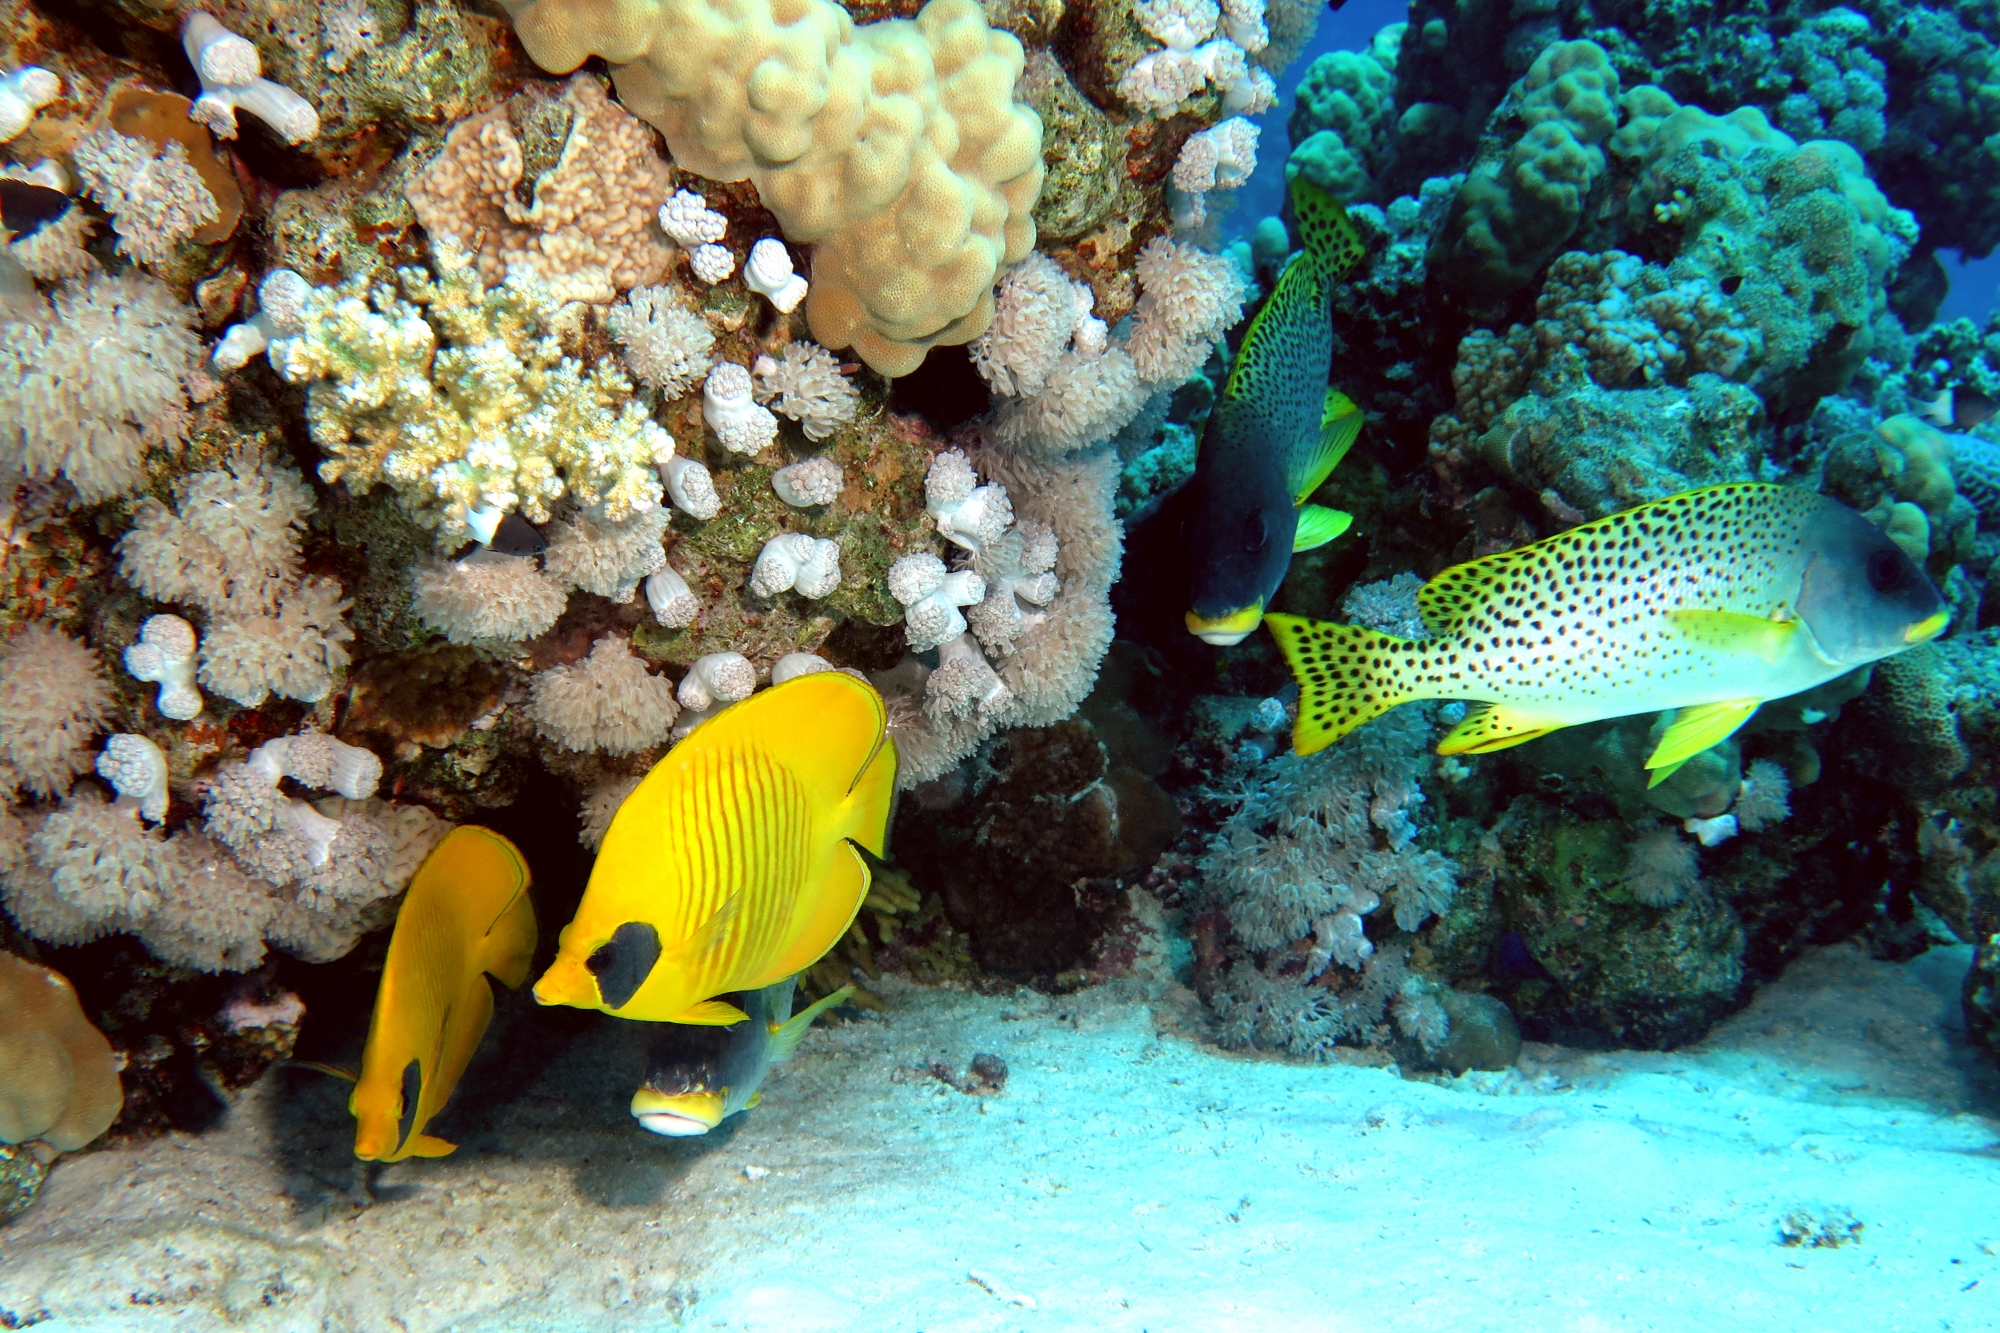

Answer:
[0,947,2000,1333]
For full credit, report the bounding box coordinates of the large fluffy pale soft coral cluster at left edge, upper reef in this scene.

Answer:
[0,272,202,502]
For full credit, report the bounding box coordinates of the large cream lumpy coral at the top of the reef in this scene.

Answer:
[506,0,1042,376]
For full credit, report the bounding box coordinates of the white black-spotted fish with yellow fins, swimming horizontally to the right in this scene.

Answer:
[1266,482,1950,785]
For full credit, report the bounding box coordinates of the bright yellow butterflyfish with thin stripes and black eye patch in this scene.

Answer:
[534,671,896,1027]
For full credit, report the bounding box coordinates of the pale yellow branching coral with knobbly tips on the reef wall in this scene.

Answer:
[270,250,674,544]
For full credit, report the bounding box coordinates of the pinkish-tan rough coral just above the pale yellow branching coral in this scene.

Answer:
[404,74,674,304]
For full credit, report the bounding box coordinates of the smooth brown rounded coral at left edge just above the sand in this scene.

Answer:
[0,953,124,1153]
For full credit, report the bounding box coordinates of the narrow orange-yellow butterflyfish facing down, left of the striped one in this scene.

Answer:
[348,825,534,1161]
